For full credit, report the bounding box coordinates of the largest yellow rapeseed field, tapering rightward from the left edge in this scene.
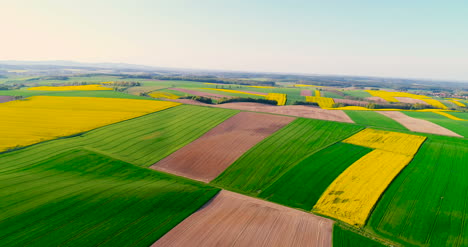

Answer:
[0,96,179,152]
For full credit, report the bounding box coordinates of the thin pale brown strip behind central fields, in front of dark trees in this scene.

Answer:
[216,102,354,123]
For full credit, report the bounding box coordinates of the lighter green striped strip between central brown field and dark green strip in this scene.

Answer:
[213,119,362,195]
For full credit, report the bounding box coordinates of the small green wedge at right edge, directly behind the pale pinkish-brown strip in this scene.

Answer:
[403,111,468,138]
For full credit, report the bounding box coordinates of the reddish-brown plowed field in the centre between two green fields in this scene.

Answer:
[151,112,295,182]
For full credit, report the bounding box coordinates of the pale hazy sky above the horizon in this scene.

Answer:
[0,0,468,81]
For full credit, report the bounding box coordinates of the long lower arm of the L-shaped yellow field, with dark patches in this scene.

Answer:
[314,150,412,227]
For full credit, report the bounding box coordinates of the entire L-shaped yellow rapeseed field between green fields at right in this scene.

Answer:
[314,129,426,227]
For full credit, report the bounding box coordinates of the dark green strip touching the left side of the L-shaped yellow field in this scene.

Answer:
[259,142,372,211]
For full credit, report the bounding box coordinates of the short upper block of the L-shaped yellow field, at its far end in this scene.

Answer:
[343,129,426,155]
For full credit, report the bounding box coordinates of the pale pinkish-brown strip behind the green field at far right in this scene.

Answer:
[377,111,462,137]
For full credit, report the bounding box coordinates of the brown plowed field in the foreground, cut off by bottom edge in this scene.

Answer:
[152,191,333,247]
